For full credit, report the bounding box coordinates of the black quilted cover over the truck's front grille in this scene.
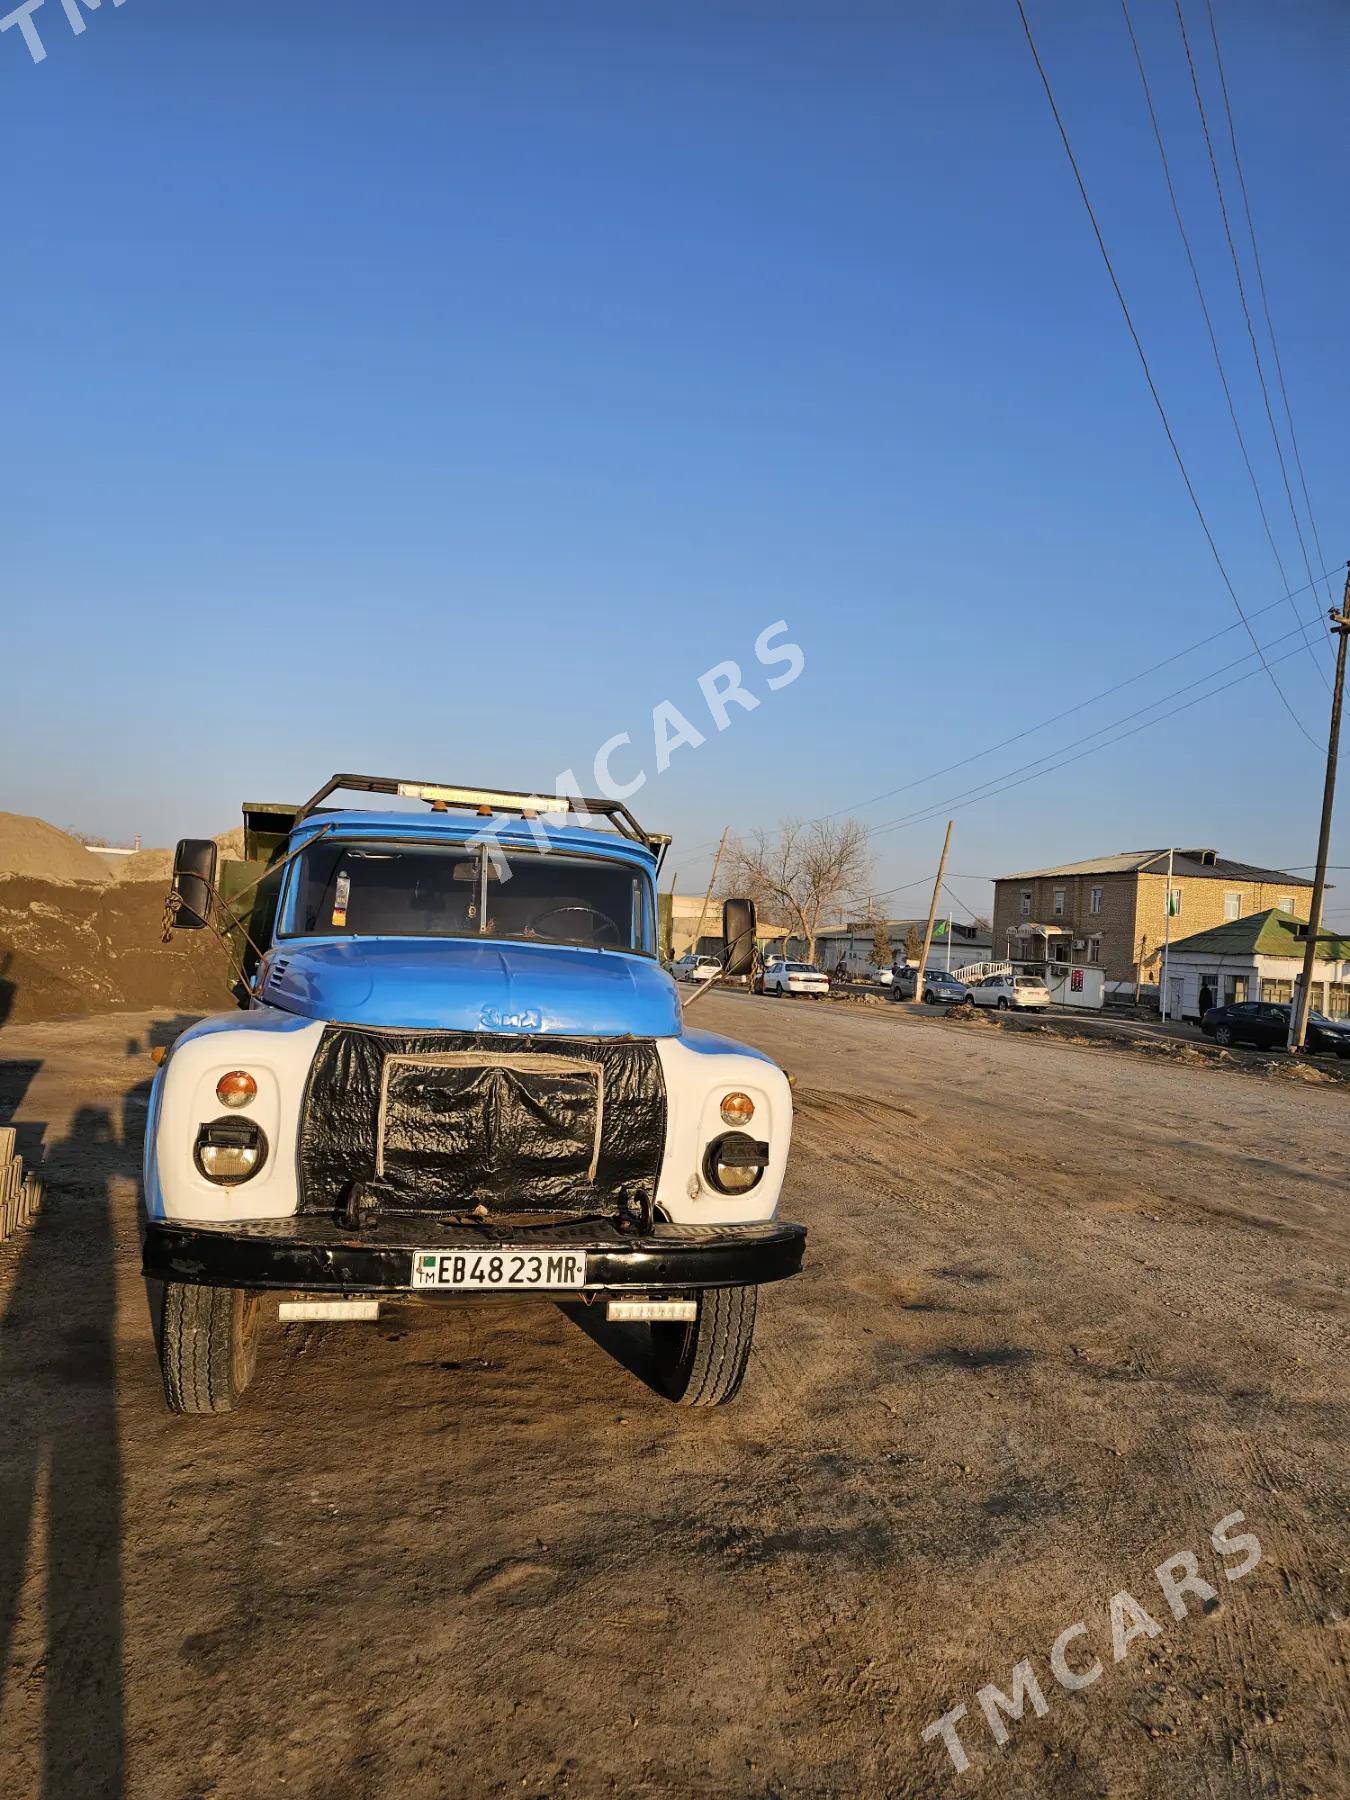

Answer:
[299,1026,666,1213]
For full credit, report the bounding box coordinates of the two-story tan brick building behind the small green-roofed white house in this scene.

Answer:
[994,850,1312,986]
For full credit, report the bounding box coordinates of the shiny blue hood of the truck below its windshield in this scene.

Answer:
[257,938,680,1037]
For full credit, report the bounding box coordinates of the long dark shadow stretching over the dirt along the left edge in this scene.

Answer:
[0,1017,189,1800]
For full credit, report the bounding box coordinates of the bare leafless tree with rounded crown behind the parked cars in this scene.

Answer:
[722,819,871,963]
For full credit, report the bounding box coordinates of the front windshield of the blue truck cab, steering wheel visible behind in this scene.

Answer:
[277,839,653,954]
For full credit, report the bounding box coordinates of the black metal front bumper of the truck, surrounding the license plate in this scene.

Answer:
[142,1217,806,1300]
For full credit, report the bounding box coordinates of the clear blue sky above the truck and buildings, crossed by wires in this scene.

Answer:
[0,0,1350,918]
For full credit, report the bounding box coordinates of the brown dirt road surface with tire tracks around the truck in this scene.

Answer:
[0,995,1350,1800]
